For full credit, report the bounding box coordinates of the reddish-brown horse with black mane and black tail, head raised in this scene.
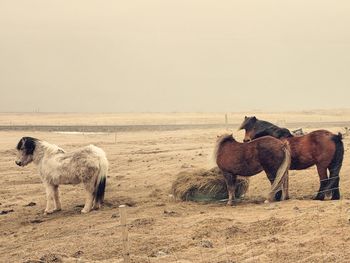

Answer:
[239,116,344,200]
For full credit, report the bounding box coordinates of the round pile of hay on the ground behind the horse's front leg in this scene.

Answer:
[171,167,249,201]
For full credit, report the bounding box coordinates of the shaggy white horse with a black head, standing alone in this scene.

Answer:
[16,137,108,214]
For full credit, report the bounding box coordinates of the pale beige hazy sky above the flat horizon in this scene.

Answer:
[0,0,350,112]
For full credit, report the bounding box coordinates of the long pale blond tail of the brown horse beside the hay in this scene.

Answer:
[271,141,292,200]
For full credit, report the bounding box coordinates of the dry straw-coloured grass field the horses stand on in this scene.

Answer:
[0,110,350,263]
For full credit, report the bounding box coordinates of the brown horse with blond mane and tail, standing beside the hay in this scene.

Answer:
[215,135,291,205]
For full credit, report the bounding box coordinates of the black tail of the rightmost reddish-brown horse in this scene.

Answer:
[325,133,344,199]
